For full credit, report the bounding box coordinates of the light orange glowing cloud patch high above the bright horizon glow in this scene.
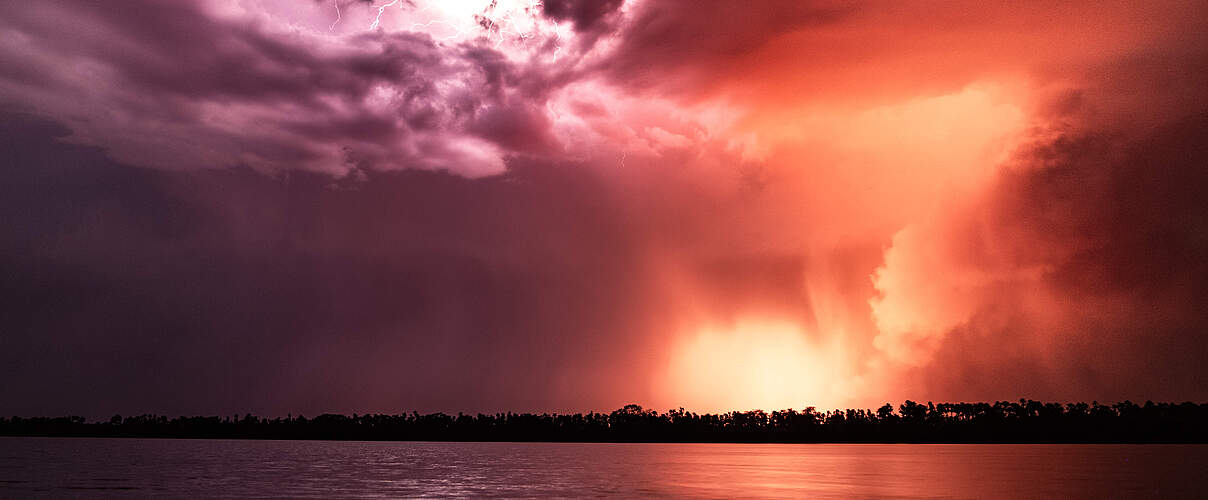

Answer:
[744,82,1028,238]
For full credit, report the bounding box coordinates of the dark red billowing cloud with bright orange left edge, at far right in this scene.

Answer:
[872,95,1208,400]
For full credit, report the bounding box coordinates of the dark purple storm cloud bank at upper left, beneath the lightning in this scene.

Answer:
[0,1,556,176]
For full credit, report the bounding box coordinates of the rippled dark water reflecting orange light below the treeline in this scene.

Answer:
[0,438,1208,499]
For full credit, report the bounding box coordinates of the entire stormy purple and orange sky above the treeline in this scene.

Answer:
[0,0,1208,417]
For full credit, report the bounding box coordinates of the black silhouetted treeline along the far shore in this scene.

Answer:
[0,400,1208,443]
